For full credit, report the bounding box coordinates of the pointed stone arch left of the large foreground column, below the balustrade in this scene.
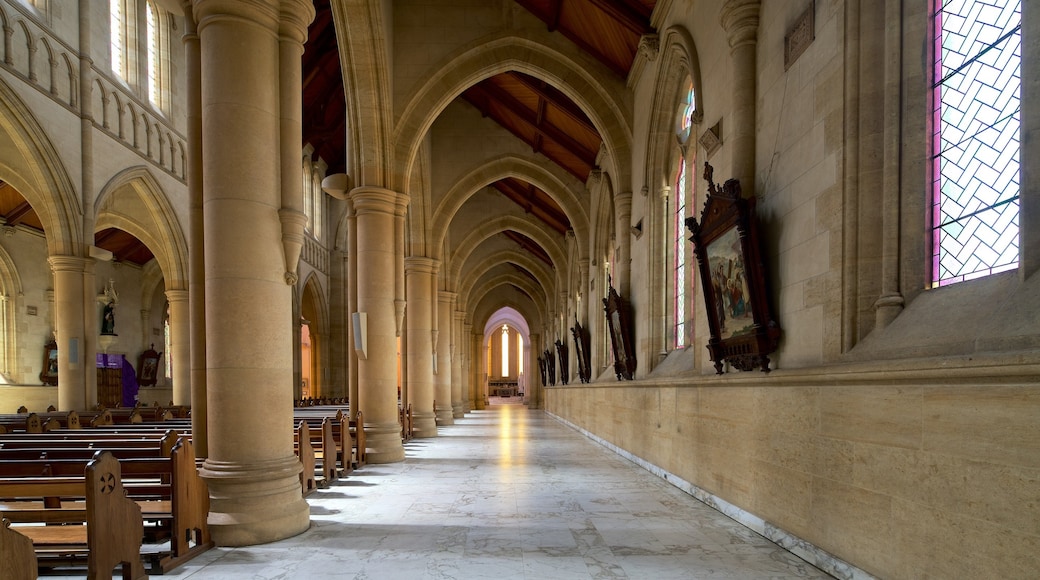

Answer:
[95,165,188,290]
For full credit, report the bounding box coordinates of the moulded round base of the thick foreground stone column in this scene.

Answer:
[200,455,311,547]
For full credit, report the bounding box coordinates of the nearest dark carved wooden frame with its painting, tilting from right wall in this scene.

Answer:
[686,163,781,374]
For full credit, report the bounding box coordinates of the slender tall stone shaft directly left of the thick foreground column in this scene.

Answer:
[182,0,209,457]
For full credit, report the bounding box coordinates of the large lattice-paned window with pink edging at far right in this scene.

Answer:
[930,0,1021,287]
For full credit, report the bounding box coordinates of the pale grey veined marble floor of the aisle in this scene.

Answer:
[48,404,830,580]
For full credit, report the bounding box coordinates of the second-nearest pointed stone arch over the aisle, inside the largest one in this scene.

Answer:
[428,155,589,264]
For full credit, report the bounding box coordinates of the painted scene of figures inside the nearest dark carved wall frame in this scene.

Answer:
[708,228,755,340]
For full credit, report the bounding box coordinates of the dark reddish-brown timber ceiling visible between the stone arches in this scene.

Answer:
[304,0,656,262]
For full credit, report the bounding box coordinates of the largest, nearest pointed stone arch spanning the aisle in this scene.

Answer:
[393,32,632,198]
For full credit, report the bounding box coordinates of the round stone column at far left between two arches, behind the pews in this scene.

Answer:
[47,256,90,411]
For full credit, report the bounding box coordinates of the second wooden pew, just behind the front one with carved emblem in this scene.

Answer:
[0,431,213,574]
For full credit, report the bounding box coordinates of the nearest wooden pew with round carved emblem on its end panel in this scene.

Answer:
[0,451,148,580]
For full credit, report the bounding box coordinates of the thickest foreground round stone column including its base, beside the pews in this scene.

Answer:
[194,0,310,546]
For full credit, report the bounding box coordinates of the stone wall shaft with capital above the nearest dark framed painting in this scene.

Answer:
[719,0,759,197]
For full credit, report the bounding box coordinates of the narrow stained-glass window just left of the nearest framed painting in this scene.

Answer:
[672,81,696,348]
